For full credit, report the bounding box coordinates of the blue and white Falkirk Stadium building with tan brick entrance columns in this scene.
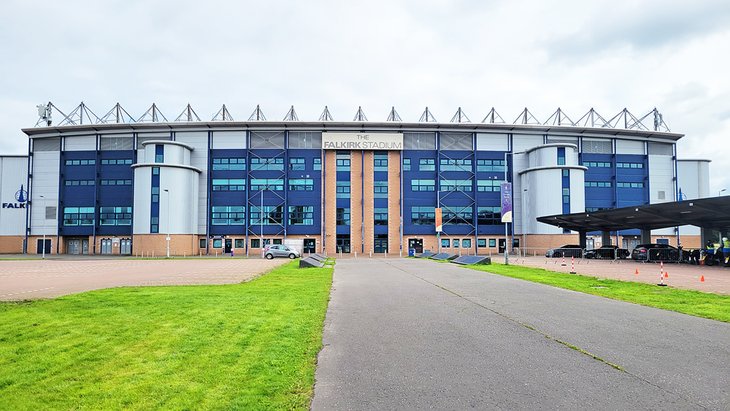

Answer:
[0,103,709,256]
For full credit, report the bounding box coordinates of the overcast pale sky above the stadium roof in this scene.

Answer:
[0,0,730,194]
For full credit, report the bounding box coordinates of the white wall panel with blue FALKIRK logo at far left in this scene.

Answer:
[0,157,28,235]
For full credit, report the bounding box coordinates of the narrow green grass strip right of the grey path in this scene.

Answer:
[468,264,730,322]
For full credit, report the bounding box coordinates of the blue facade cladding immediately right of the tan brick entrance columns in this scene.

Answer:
[400,150,438,235]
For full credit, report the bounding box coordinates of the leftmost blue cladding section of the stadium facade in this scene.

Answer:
[58,150,97,236]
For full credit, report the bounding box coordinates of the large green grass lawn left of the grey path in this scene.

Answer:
[0,262,332,410]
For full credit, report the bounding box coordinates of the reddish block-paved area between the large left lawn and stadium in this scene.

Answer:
[0,257,289,300]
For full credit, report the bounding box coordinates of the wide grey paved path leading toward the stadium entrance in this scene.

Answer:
[312,258,730,410]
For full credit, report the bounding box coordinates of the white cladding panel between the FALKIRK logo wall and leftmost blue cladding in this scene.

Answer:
[30,151,61,235]
